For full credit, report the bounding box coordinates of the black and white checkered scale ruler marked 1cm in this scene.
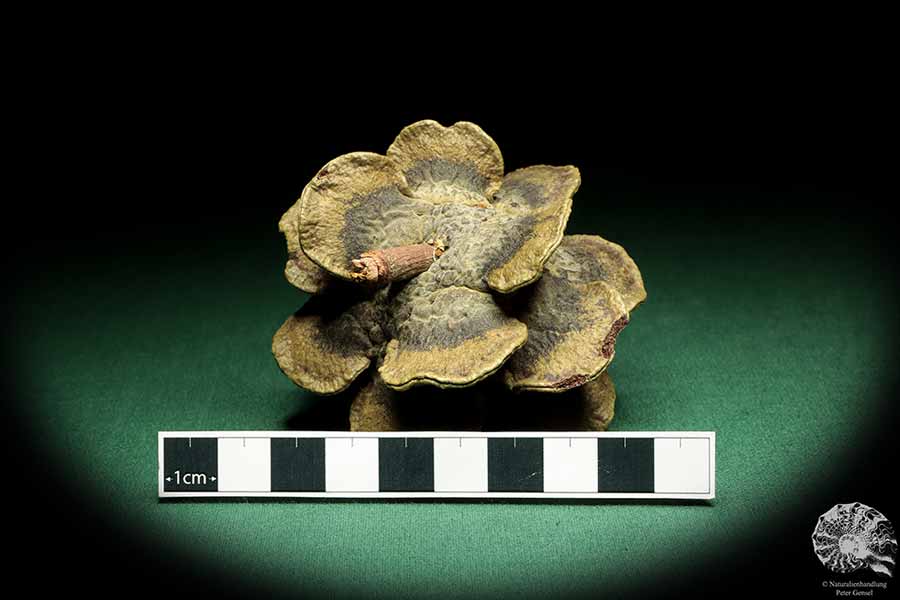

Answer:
[159,431,716,500]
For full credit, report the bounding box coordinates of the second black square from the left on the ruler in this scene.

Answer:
[271,438,325,492]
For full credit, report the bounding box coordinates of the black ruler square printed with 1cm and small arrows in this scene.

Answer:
[163,437,219,492]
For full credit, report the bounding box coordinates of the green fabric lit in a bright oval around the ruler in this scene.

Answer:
[17,182,895,597]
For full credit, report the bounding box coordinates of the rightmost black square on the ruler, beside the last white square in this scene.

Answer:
[597,438,654,492]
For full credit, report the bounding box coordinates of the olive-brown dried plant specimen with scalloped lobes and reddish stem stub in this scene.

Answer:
[272,121,646,429]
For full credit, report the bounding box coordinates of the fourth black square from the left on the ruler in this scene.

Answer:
[488,438,544,492]
